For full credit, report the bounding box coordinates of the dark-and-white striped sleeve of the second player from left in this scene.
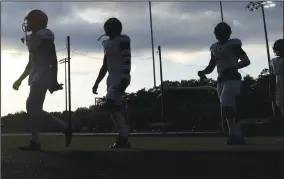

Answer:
[119,35,131,74]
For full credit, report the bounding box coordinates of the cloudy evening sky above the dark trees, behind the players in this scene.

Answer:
[1,2,283,116]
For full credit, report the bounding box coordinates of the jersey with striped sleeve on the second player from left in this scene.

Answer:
[103,35,131,85]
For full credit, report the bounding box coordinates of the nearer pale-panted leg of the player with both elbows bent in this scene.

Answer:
[221,80,244,144]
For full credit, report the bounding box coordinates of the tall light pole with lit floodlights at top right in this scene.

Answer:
[246,1,275,72]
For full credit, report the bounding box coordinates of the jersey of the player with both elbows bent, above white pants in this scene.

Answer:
[210,39,242,83]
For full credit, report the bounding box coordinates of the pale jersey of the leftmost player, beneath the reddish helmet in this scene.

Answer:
[27,29,54,85]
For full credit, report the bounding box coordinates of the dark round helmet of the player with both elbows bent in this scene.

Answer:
[214,22,232,42]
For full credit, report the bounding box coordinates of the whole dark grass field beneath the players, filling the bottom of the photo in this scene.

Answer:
[1,135,284,179]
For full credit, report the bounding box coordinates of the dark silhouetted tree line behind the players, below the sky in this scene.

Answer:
[1,69,280,133]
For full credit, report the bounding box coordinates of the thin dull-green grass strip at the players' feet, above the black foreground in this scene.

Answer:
[1,136,283,151]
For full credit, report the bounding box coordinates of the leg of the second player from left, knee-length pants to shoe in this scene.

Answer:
[106,86,130,148]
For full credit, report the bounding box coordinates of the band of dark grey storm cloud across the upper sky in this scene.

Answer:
[1,2,282,52]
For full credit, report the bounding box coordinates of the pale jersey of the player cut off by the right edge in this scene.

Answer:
[270,57,284,109]
